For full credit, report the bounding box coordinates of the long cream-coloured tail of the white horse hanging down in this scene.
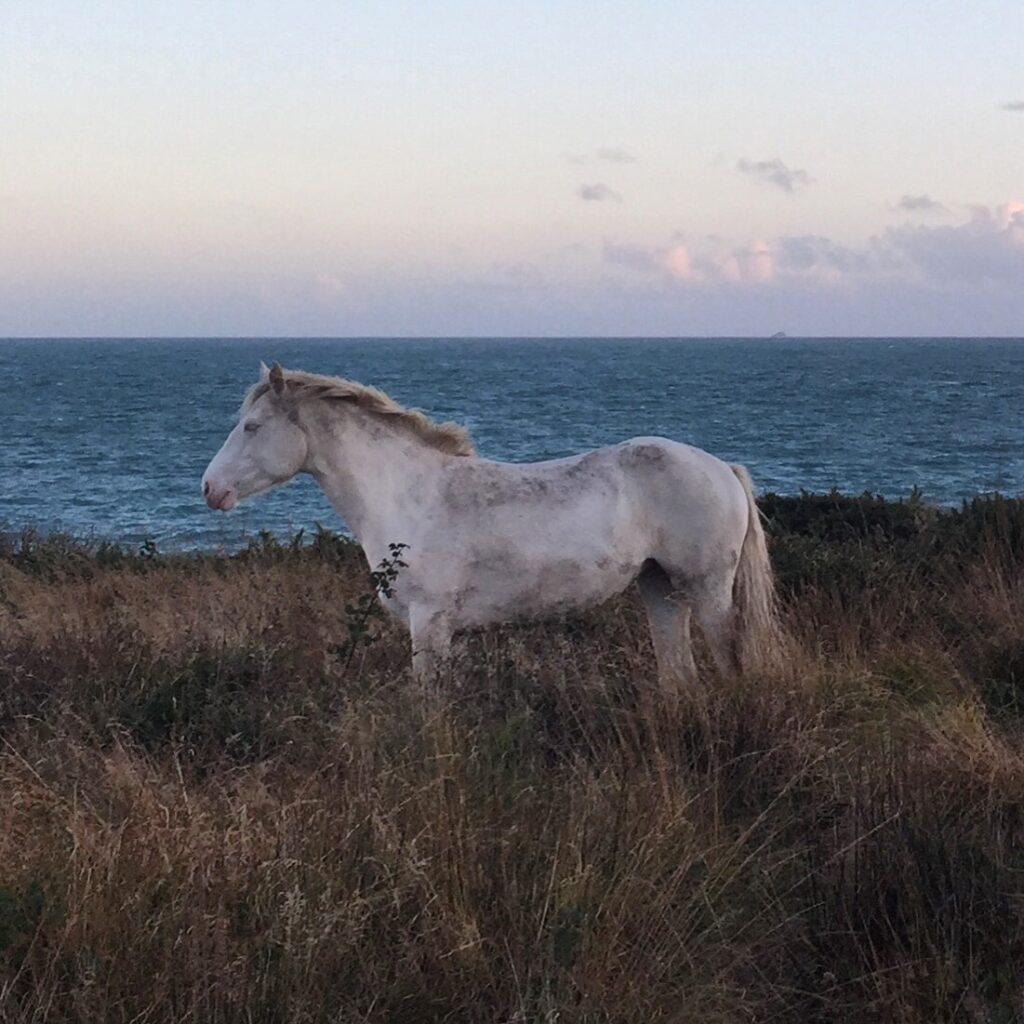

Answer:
[729,466,779,672]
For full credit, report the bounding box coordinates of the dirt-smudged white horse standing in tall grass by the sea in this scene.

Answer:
[203,362,775,684]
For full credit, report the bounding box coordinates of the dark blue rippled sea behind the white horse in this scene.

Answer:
[0,339,1024,548]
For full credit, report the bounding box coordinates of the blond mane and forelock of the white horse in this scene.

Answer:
[242,370,476,456]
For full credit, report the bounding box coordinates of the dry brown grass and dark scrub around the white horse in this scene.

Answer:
[0,495,1024,1024]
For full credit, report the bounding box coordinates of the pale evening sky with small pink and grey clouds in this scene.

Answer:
[0,0,1024,337]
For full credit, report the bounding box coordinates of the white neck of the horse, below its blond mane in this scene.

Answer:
[304,407,451,562]
